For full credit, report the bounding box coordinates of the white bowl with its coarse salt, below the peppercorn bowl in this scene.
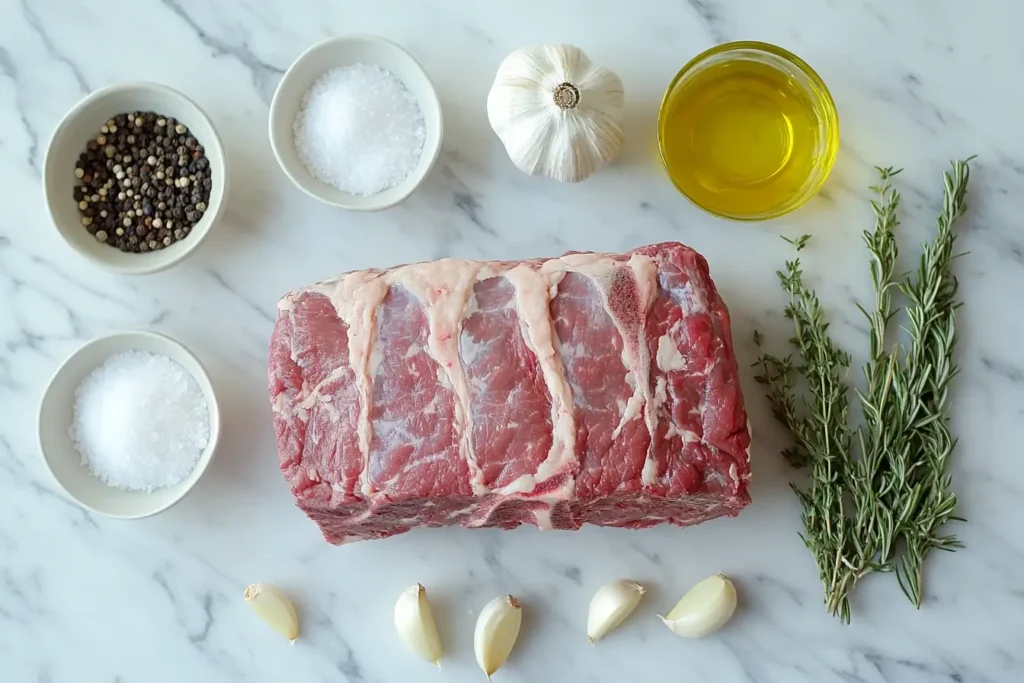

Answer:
[39,331,220,519]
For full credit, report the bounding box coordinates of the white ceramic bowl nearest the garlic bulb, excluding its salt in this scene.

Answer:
[269,36,443,211]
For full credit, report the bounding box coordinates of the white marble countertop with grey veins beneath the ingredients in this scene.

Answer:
[0,0,1024,683]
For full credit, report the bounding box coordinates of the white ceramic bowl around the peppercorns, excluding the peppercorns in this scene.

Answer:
[43,82,227,275]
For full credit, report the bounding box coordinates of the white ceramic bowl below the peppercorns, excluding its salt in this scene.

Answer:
[39,331,220,519]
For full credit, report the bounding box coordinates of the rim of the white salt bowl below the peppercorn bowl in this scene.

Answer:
[36,330,220,520]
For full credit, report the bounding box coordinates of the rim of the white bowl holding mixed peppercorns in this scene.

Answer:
[42,81,230,275]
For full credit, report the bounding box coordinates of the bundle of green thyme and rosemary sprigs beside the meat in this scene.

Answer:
[754,159,971,623]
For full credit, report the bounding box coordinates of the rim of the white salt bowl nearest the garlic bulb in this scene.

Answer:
[267,33,444,213]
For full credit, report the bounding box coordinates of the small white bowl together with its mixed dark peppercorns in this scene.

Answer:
[43,82,228,274]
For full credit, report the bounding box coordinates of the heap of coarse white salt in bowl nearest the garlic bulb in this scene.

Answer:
[293,63,426,196]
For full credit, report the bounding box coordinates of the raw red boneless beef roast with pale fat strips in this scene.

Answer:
[269,243,750,543]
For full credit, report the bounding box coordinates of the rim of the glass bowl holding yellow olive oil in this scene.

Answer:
[657,40,840,223]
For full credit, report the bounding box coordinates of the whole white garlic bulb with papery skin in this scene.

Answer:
[487,45,625,182]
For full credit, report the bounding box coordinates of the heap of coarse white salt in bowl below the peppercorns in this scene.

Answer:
[71,351,210,492]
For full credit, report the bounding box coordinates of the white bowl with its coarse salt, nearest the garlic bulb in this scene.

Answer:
[269,35,443,211]
